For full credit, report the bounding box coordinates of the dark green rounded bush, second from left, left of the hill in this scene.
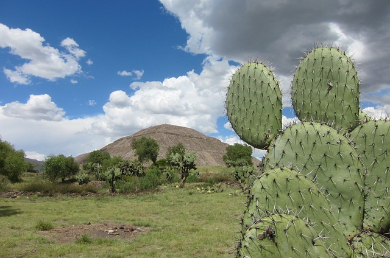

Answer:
[43,154,79,182]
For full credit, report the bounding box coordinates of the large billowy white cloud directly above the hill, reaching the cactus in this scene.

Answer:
[94,57,235,135]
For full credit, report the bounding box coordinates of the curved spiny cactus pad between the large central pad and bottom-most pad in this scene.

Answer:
[242,168,351,257]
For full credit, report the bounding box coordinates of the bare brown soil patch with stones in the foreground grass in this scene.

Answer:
[39,222,150,244]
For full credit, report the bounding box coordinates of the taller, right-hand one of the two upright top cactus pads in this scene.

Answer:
[292,47,360,131]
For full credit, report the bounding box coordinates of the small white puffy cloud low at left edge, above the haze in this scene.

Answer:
[0,94,65,121]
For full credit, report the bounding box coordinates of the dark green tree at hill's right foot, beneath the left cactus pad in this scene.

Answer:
[223,143,253,167]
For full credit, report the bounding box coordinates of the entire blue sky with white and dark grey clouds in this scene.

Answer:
[0,0,390,160]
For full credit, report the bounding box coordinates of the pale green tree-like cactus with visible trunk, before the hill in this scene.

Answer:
[167,143,196,188]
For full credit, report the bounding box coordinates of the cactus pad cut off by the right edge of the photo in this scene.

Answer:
[350,121,390,233]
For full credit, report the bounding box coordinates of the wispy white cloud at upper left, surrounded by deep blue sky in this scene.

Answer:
[0,23,85,84]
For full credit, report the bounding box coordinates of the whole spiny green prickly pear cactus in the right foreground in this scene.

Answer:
[226,47,390,257]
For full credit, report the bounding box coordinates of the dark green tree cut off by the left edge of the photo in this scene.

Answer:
[0,139,27,182]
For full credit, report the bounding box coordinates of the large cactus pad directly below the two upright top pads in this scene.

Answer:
[264,122,364,237]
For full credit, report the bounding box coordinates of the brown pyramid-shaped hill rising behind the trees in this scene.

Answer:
[76,124,232,167]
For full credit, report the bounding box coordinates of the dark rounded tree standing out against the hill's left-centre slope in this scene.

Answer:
[131,137,159,164]
